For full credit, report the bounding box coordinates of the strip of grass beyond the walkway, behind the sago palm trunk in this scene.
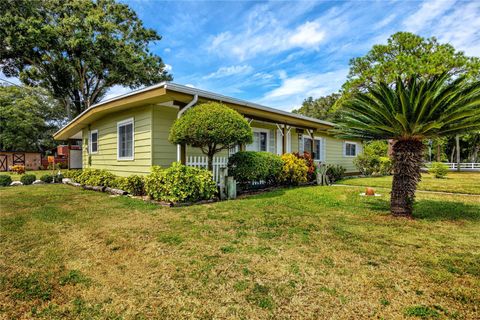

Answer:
[338,172,480,195]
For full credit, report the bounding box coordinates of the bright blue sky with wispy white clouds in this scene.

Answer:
[3,0,480,111]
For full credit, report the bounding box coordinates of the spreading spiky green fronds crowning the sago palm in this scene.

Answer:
[335,73,480,140]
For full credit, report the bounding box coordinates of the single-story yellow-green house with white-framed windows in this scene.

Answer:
[54,82,362,176]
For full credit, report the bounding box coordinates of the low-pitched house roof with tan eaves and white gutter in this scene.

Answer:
[53,82,335,140]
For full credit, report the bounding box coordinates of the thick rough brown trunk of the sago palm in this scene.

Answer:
[390,140,424,218]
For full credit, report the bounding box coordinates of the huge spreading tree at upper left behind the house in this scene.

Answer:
[0,0,172,116]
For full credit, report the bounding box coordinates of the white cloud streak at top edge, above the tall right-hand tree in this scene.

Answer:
[403,0,455,32]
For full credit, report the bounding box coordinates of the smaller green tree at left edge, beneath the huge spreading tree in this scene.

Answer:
[0,86,65,152]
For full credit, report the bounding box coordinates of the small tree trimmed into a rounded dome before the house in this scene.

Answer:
[169,102,253,170]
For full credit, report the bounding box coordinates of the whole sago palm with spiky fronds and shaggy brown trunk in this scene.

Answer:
[336,74,480,217]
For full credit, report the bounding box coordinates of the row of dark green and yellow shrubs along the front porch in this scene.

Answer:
[228,151,346,188]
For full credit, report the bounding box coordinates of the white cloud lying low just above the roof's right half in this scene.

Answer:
[258,69,348,111]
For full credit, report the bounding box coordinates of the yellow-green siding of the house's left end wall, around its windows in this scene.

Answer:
[83,106,152,176]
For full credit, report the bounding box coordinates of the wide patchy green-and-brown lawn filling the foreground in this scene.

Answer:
[0,185,480,319]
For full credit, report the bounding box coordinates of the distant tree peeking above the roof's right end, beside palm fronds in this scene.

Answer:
[292,93,340,121]
